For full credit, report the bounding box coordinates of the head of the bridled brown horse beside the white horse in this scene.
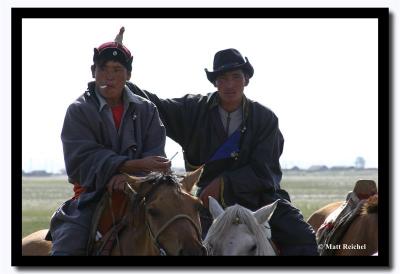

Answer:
[123,169,206,255]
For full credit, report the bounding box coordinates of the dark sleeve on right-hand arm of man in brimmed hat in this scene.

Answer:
[222,111,284,209]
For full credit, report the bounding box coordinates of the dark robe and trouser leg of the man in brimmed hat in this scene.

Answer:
[127,83,317,255]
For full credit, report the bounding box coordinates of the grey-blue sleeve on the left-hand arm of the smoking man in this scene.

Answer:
[61,102,128,207]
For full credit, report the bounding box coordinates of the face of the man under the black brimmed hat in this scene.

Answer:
[215,69,247,107]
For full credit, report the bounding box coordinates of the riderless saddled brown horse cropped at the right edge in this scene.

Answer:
[307,180,378,256]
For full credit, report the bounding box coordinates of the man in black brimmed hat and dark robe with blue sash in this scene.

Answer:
[128,49,318,255]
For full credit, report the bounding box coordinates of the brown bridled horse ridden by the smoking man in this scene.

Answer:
[22,169,206,256]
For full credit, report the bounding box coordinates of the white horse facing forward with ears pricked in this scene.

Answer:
[204,197,278,256]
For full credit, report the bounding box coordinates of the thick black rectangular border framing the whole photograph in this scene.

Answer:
[11,8,393,271]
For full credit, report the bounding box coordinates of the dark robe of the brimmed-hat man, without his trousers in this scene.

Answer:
[129,82,289,210]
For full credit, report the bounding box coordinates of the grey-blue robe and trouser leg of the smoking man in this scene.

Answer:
[50,82,166,253]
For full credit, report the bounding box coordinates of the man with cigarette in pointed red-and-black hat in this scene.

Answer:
[50,28,171,255]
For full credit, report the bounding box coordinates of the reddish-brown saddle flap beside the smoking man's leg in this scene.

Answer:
[87,192,129,256]
